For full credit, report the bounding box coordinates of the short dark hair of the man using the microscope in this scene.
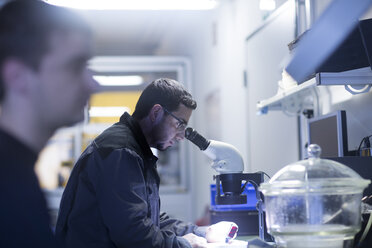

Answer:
[133,78,197,120]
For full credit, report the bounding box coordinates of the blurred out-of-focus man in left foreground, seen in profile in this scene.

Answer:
[0,0,95,247]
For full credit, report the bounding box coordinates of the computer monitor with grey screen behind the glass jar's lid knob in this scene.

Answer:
[308,110,348,158]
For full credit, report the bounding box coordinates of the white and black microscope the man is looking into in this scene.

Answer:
[185,127,271,241]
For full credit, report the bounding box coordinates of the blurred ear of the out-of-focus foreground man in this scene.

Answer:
[1,58,30,94]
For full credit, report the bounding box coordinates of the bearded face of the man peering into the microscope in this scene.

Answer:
[153,104,192,151]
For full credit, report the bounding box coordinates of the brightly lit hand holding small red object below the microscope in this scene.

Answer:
[205,221,238,243]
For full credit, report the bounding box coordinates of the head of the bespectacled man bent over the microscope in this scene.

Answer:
[133,78,197,150]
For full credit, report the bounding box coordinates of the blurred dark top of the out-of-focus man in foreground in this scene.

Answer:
[0,129,57,248]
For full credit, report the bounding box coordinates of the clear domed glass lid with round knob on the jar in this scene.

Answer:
[260,144,370,194]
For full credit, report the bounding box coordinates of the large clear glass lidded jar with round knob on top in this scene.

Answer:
[260,144,370,248]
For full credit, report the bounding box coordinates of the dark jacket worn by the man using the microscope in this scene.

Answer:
[56,113,203,248]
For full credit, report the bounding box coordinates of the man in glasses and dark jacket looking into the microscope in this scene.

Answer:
[56,78,230,248]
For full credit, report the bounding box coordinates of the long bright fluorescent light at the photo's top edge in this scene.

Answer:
[43,0,217,10]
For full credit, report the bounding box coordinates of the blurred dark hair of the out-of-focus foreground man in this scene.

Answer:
[0,0,91,101]
